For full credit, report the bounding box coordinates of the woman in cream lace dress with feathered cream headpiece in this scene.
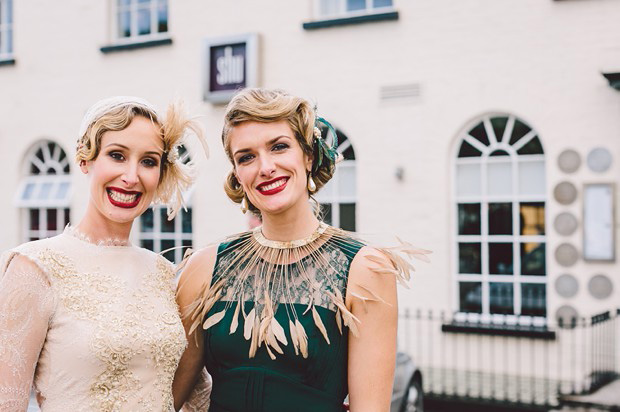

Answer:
[0,97,208,412]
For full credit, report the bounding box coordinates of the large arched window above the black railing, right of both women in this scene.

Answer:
[453,115,547,317]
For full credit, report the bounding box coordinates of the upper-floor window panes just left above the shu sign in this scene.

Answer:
[114,0,168,42]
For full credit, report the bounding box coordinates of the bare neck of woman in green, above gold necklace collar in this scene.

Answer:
[262,201,319,242]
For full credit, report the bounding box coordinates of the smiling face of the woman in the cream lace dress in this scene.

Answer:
[81,116,163,223]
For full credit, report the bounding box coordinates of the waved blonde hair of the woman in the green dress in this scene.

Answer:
[222,88,335,215]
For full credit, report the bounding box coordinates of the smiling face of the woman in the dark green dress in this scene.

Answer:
[228,120,312,215]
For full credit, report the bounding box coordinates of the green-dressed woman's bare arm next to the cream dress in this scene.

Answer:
[172,246,217,410]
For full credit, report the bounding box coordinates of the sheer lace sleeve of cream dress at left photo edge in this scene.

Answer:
[0,254,54,411]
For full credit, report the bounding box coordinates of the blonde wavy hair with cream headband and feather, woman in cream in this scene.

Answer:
[75,96,208,220]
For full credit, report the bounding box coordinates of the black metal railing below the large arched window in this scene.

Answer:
[399,309,620,409]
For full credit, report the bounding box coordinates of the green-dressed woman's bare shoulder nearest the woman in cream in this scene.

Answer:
[177,245,217,304]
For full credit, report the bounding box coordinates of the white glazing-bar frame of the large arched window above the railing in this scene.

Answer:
[451,112,549,324]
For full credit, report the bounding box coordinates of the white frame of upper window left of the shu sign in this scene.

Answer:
[110,0,170,45]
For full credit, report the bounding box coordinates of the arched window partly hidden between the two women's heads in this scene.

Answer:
[139,146,193,263]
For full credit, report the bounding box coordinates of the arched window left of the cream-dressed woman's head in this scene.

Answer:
[16,140,71,241]
